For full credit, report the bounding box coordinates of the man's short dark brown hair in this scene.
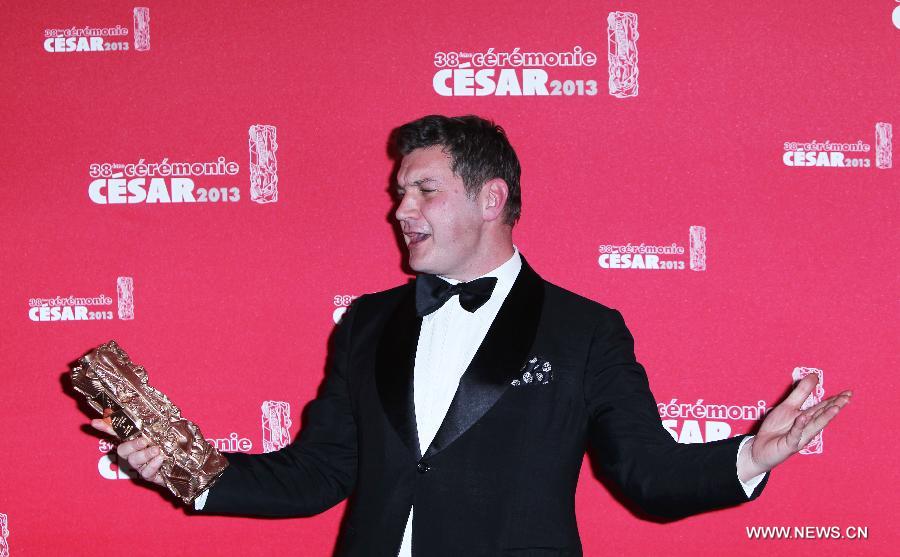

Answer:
[390,114,522,226]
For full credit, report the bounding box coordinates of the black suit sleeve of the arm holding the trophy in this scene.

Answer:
[203,300,359,517]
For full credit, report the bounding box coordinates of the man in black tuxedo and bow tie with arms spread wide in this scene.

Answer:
[94,116,850,557]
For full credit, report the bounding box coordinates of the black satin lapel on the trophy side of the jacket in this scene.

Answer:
[375,287,422,460]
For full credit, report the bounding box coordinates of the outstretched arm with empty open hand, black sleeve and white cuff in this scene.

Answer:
[585,311,850,518]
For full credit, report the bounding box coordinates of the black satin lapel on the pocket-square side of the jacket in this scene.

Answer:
[425,258,544,458]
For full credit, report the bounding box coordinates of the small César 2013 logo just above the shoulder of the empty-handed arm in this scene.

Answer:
[598,226,706,271]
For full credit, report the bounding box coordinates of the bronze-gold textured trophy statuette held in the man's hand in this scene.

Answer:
[72,340,228,503]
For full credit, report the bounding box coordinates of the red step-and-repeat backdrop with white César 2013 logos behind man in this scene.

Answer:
[0,0,900,557]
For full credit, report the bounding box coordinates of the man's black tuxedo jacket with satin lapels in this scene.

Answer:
[204,260,762,557]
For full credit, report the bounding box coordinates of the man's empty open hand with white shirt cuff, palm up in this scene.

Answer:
[738,374,853,481]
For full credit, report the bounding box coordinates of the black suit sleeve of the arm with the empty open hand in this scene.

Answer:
[584,310,765,518]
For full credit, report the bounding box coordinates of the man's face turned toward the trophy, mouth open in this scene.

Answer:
[395,147,484,280]
